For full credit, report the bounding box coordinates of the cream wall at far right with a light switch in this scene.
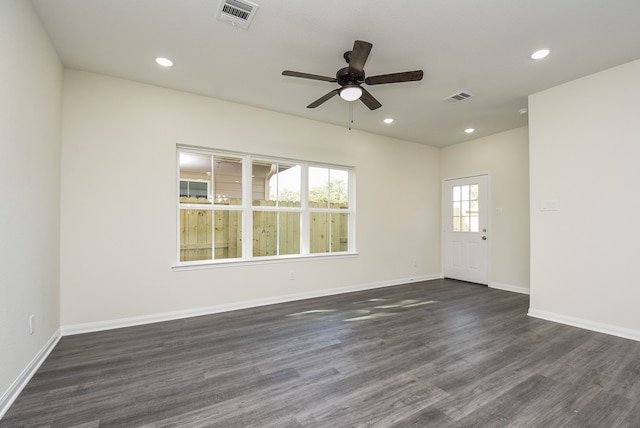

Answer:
[529,60,640,339]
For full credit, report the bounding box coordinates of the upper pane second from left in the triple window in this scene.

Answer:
[213,156,242,205]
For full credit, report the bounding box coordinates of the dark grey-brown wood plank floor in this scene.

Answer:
[0,280,640,428]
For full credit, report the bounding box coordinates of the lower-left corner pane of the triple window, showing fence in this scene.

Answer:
[180,209,212,262]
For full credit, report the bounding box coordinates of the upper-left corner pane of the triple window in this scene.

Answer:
[180,152,212,204]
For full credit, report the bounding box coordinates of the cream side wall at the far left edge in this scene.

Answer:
[0,0,62,415]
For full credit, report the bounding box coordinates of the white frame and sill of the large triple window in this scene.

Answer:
[173,145,357,270]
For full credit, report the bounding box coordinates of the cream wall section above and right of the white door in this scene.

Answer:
[440,127,529,293]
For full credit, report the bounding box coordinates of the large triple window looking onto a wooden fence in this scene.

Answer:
[178,147,355,264]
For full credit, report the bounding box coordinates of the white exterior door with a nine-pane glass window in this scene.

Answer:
[443,175,489,285]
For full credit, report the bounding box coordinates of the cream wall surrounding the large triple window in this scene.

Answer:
[61,70,440,326]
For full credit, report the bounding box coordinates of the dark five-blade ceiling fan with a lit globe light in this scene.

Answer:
[282,40,423,110]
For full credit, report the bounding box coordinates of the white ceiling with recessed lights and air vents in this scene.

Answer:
[33,0,640,146]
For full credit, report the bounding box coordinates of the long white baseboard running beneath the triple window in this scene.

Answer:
[61,274,442,336]
